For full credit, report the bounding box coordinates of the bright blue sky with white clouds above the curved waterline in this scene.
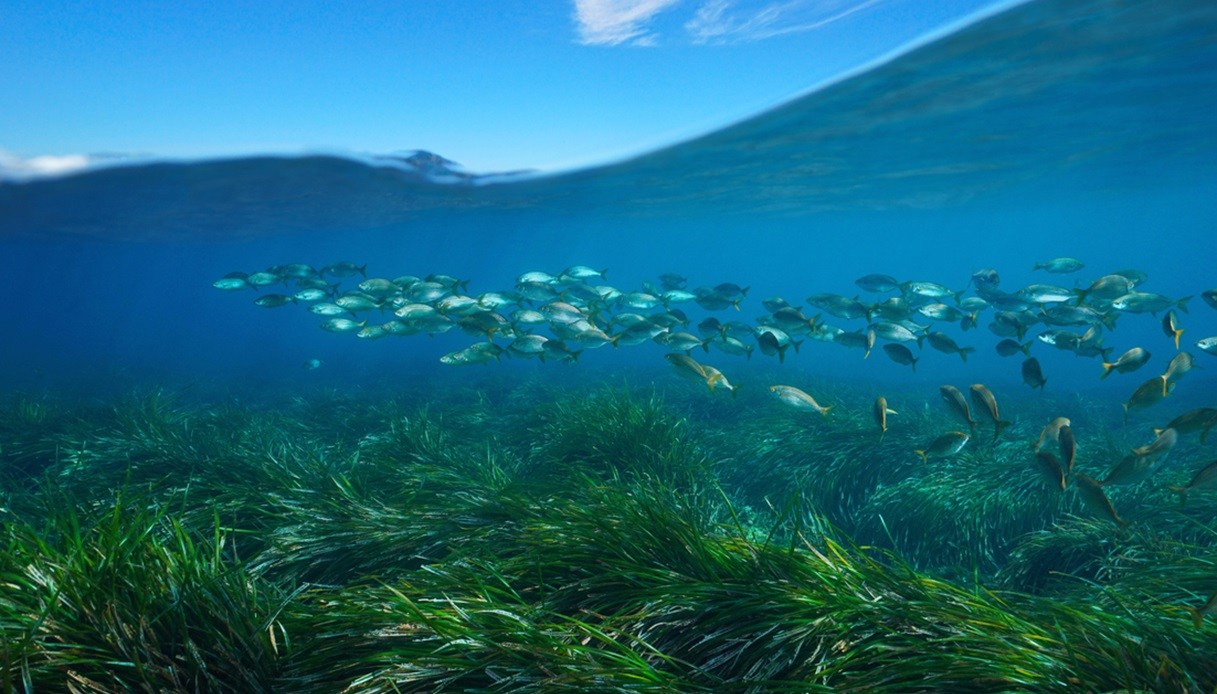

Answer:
[0,0,997,172]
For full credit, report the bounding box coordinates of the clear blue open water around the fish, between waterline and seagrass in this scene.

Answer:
[0,1,1217,397]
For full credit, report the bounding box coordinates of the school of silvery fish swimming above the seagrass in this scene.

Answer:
[213,258,1217,616]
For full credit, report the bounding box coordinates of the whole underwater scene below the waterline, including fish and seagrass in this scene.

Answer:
[0,0,1217,693]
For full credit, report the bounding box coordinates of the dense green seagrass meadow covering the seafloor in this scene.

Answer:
[0,381,1217,692]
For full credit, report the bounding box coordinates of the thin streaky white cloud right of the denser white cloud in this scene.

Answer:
[685,0,882,44]
